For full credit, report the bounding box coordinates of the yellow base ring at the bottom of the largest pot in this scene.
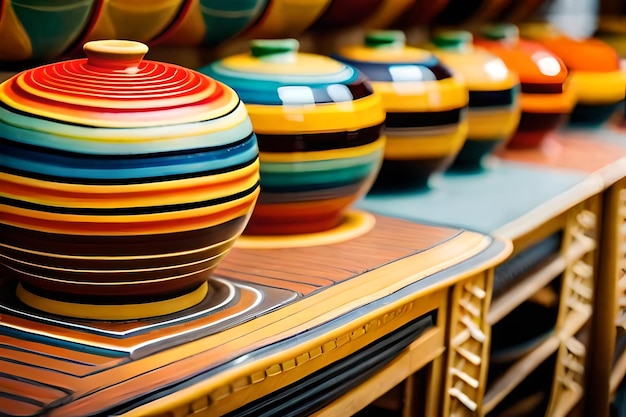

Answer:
[16,282,209,320]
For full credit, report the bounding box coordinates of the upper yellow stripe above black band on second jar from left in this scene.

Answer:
[246,94,385,134]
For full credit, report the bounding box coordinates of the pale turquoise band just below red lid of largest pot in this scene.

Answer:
[0,103,252,155]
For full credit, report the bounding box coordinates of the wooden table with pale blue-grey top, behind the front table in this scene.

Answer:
[361,130,626,416]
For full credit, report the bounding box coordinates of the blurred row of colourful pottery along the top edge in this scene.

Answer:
[0,0,542,62]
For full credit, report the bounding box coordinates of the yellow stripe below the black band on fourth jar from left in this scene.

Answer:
[467,106,521,140]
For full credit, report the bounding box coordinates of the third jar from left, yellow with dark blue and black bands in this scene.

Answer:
[335,31,468,190]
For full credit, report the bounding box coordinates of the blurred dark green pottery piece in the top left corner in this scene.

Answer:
[0,0,102,67]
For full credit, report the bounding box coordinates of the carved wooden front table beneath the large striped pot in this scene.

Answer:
[0,213,511,417]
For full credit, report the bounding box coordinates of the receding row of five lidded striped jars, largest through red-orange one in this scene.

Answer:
[0,26,624,319]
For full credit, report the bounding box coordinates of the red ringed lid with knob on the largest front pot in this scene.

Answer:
[0,40,239,128]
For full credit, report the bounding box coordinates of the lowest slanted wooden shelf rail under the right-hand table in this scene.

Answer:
[483,335,561,414]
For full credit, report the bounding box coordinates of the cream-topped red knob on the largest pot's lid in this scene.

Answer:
[83,40,148,74]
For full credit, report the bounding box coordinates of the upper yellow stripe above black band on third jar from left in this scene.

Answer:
[372,77,469,112]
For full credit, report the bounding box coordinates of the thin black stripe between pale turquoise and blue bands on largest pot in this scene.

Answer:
[0,132,254,160]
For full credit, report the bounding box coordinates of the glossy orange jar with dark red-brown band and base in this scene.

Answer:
[474,23,574,148]
